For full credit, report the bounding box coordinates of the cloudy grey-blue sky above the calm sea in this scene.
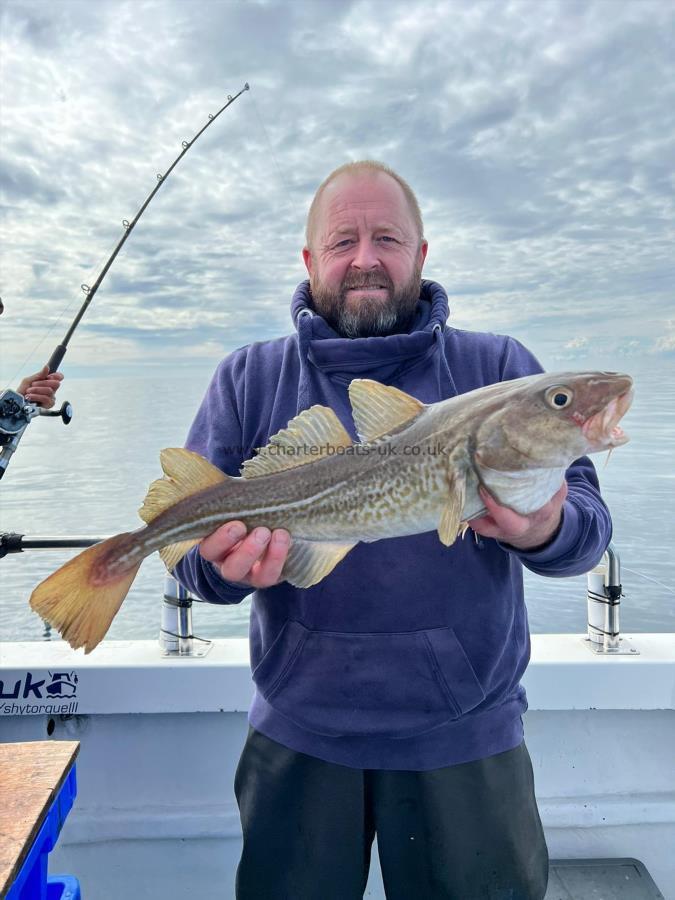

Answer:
[0,0,675,387]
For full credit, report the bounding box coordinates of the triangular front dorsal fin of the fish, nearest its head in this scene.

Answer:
[349,378,425,443]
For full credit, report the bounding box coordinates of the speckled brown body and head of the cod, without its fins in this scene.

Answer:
[117,372,632,558]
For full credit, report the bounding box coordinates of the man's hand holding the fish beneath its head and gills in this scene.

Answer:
[469,481,567,550]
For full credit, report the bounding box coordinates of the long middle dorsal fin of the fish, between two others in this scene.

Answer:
[241,406,352,478]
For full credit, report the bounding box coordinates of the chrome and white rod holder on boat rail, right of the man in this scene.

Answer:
[584,544,640,656]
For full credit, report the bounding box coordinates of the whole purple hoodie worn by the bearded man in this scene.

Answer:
[175,281,611,770]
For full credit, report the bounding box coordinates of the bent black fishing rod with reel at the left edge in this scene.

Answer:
[0,82,250,479]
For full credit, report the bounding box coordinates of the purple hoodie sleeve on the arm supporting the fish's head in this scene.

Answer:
[499,338,612,578]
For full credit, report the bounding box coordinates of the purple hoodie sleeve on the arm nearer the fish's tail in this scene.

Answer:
[173,350,252,603]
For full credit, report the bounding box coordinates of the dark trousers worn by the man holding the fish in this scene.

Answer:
[235,729,548,900]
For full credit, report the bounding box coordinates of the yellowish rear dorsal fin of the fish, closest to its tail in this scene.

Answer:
[138,447,227,523]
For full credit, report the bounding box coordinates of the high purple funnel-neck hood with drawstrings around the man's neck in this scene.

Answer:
[291,280,457,411]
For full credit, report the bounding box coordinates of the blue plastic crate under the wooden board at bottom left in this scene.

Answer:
[5,765,80,900]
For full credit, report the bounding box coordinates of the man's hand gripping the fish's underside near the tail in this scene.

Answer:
[199,522,291,588]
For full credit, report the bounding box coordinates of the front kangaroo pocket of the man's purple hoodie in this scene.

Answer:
[253,621,485,738]
